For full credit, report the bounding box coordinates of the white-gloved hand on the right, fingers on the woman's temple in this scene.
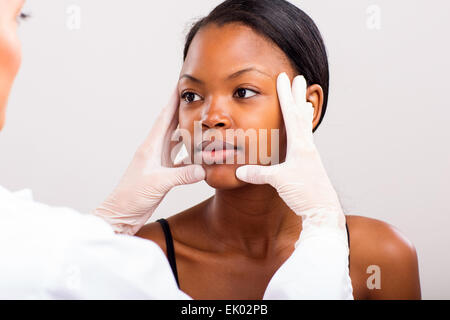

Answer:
[236,73,346,242]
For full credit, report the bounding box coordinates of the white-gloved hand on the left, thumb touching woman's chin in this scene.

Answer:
[93,88,205,235]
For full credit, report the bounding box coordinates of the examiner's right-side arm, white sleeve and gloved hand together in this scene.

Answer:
[236,73,353,299]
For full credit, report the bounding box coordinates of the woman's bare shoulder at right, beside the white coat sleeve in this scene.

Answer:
[347,215,421,299]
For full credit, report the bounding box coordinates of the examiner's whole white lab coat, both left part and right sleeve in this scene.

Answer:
[0,186,353,299]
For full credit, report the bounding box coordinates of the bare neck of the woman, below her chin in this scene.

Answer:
[206,184,301,258]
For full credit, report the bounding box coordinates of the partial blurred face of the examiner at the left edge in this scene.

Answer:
[0,0,25,130]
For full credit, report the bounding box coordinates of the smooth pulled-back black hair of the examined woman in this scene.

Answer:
[183,0,329,132]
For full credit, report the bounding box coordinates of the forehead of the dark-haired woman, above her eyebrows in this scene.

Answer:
[181,23,292,78]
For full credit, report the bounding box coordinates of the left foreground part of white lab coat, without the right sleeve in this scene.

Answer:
[0,187,189,299]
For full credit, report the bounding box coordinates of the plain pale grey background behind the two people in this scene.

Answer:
[0,0,450,299]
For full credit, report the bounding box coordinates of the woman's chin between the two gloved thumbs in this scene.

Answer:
[203,164,246,190]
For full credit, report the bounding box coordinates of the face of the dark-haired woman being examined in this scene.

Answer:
[178,23,296,189]
